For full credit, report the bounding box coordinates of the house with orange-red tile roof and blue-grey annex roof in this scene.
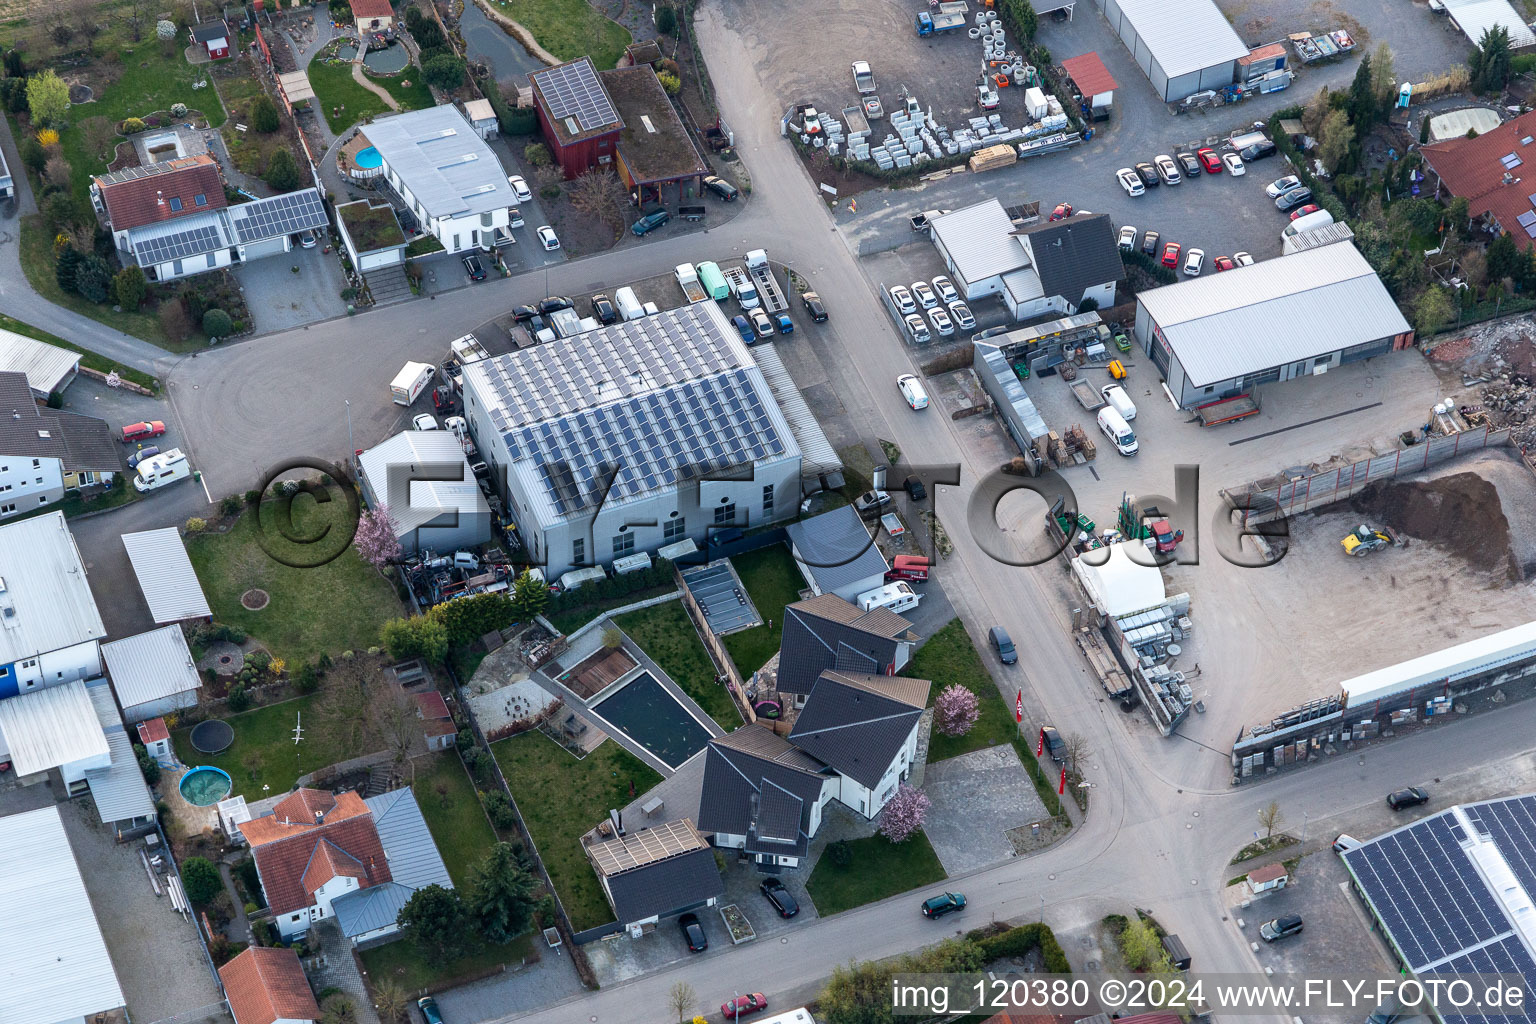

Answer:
[240,789,453,944]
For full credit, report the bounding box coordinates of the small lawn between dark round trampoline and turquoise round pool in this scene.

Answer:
[170,694,348,800]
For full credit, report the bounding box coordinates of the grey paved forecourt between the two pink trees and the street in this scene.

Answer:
[923,746,1049,875]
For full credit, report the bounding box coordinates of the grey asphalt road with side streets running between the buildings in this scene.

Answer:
[0,5,1536,1024]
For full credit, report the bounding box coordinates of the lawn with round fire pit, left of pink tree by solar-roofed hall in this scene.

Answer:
[187,493,401,660]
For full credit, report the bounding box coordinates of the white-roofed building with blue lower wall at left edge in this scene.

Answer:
[0,509,106,702]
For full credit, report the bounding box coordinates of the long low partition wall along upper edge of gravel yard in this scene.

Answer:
[1223,427,1510,527]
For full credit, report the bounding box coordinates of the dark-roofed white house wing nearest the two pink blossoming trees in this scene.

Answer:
[790,669,929,818]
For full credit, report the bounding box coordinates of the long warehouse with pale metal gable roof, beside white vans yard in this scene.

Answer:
[1135,241,1413,408]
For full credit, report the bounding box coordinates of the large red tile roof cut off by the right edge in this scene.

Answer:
[1419,112,1536,249]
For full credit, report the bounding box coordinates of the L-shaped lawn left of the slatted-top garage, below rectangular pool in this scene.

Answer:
[490,731,662,932]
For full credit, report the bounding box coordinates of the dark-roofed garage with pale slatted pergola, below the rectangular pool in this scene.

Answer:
[582,818,725,936]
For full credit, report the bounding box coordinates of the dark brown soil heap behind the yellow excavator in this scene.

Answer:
[1350,473,1522,579]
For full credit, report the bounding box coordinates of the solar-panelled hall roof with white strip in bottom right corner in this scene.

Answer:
[1344,795,1536,1024]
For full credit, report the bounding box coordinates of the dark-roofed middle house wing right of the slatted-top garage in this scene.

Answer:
[699,725,840,870]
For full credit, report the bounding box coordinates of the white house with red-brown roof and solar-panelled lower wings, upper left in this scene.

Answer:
[91,154,330,281]
